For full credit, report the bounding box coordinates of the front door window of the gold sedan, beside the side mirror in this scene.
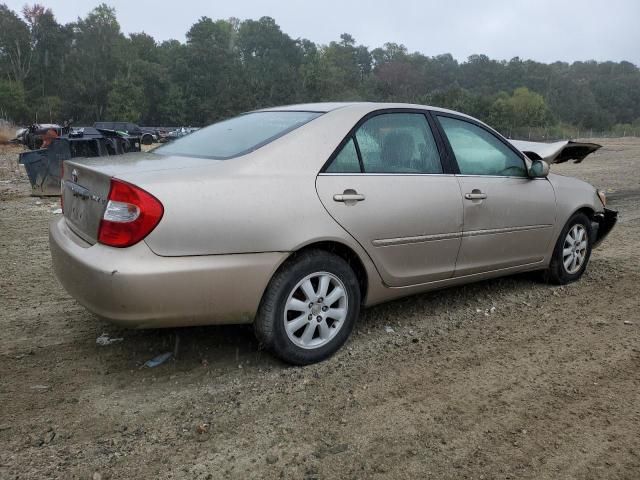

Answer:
[438,116,527,177]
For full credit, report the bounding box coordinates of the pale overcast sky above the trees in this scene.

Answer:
[5,0,640,65]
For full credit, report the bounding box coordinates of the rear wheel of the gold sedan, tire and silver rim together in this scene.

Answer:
[254,250,360,365]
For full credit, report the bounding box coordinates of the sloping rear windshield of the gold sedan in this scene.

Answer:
[154,112,322,160]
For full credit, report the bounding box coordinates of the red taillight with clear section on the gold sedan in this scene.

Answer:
[98,178,164,248]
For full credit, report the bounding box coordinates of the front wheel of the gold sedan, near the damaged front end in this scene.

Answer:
[546,213,593,285]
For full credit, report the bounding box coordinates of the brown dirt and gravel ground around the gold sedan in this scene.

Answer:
[0,139,640,479]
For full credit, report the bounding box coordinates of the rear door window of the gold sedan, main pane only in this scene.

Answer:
[355,113,442,173]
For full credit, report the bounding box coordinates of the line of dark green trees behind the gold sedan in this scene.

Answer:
[0,4,640,139]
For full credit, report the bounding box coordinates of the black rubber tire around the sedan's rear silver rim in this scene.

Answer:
[254,250,360,365]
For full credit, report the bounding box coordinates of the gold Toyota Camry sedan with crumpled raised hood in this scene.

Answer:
[50,103,617,364]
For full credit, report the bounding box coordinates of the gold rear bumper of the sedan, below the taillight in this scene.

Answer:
[49,218,286,328]
